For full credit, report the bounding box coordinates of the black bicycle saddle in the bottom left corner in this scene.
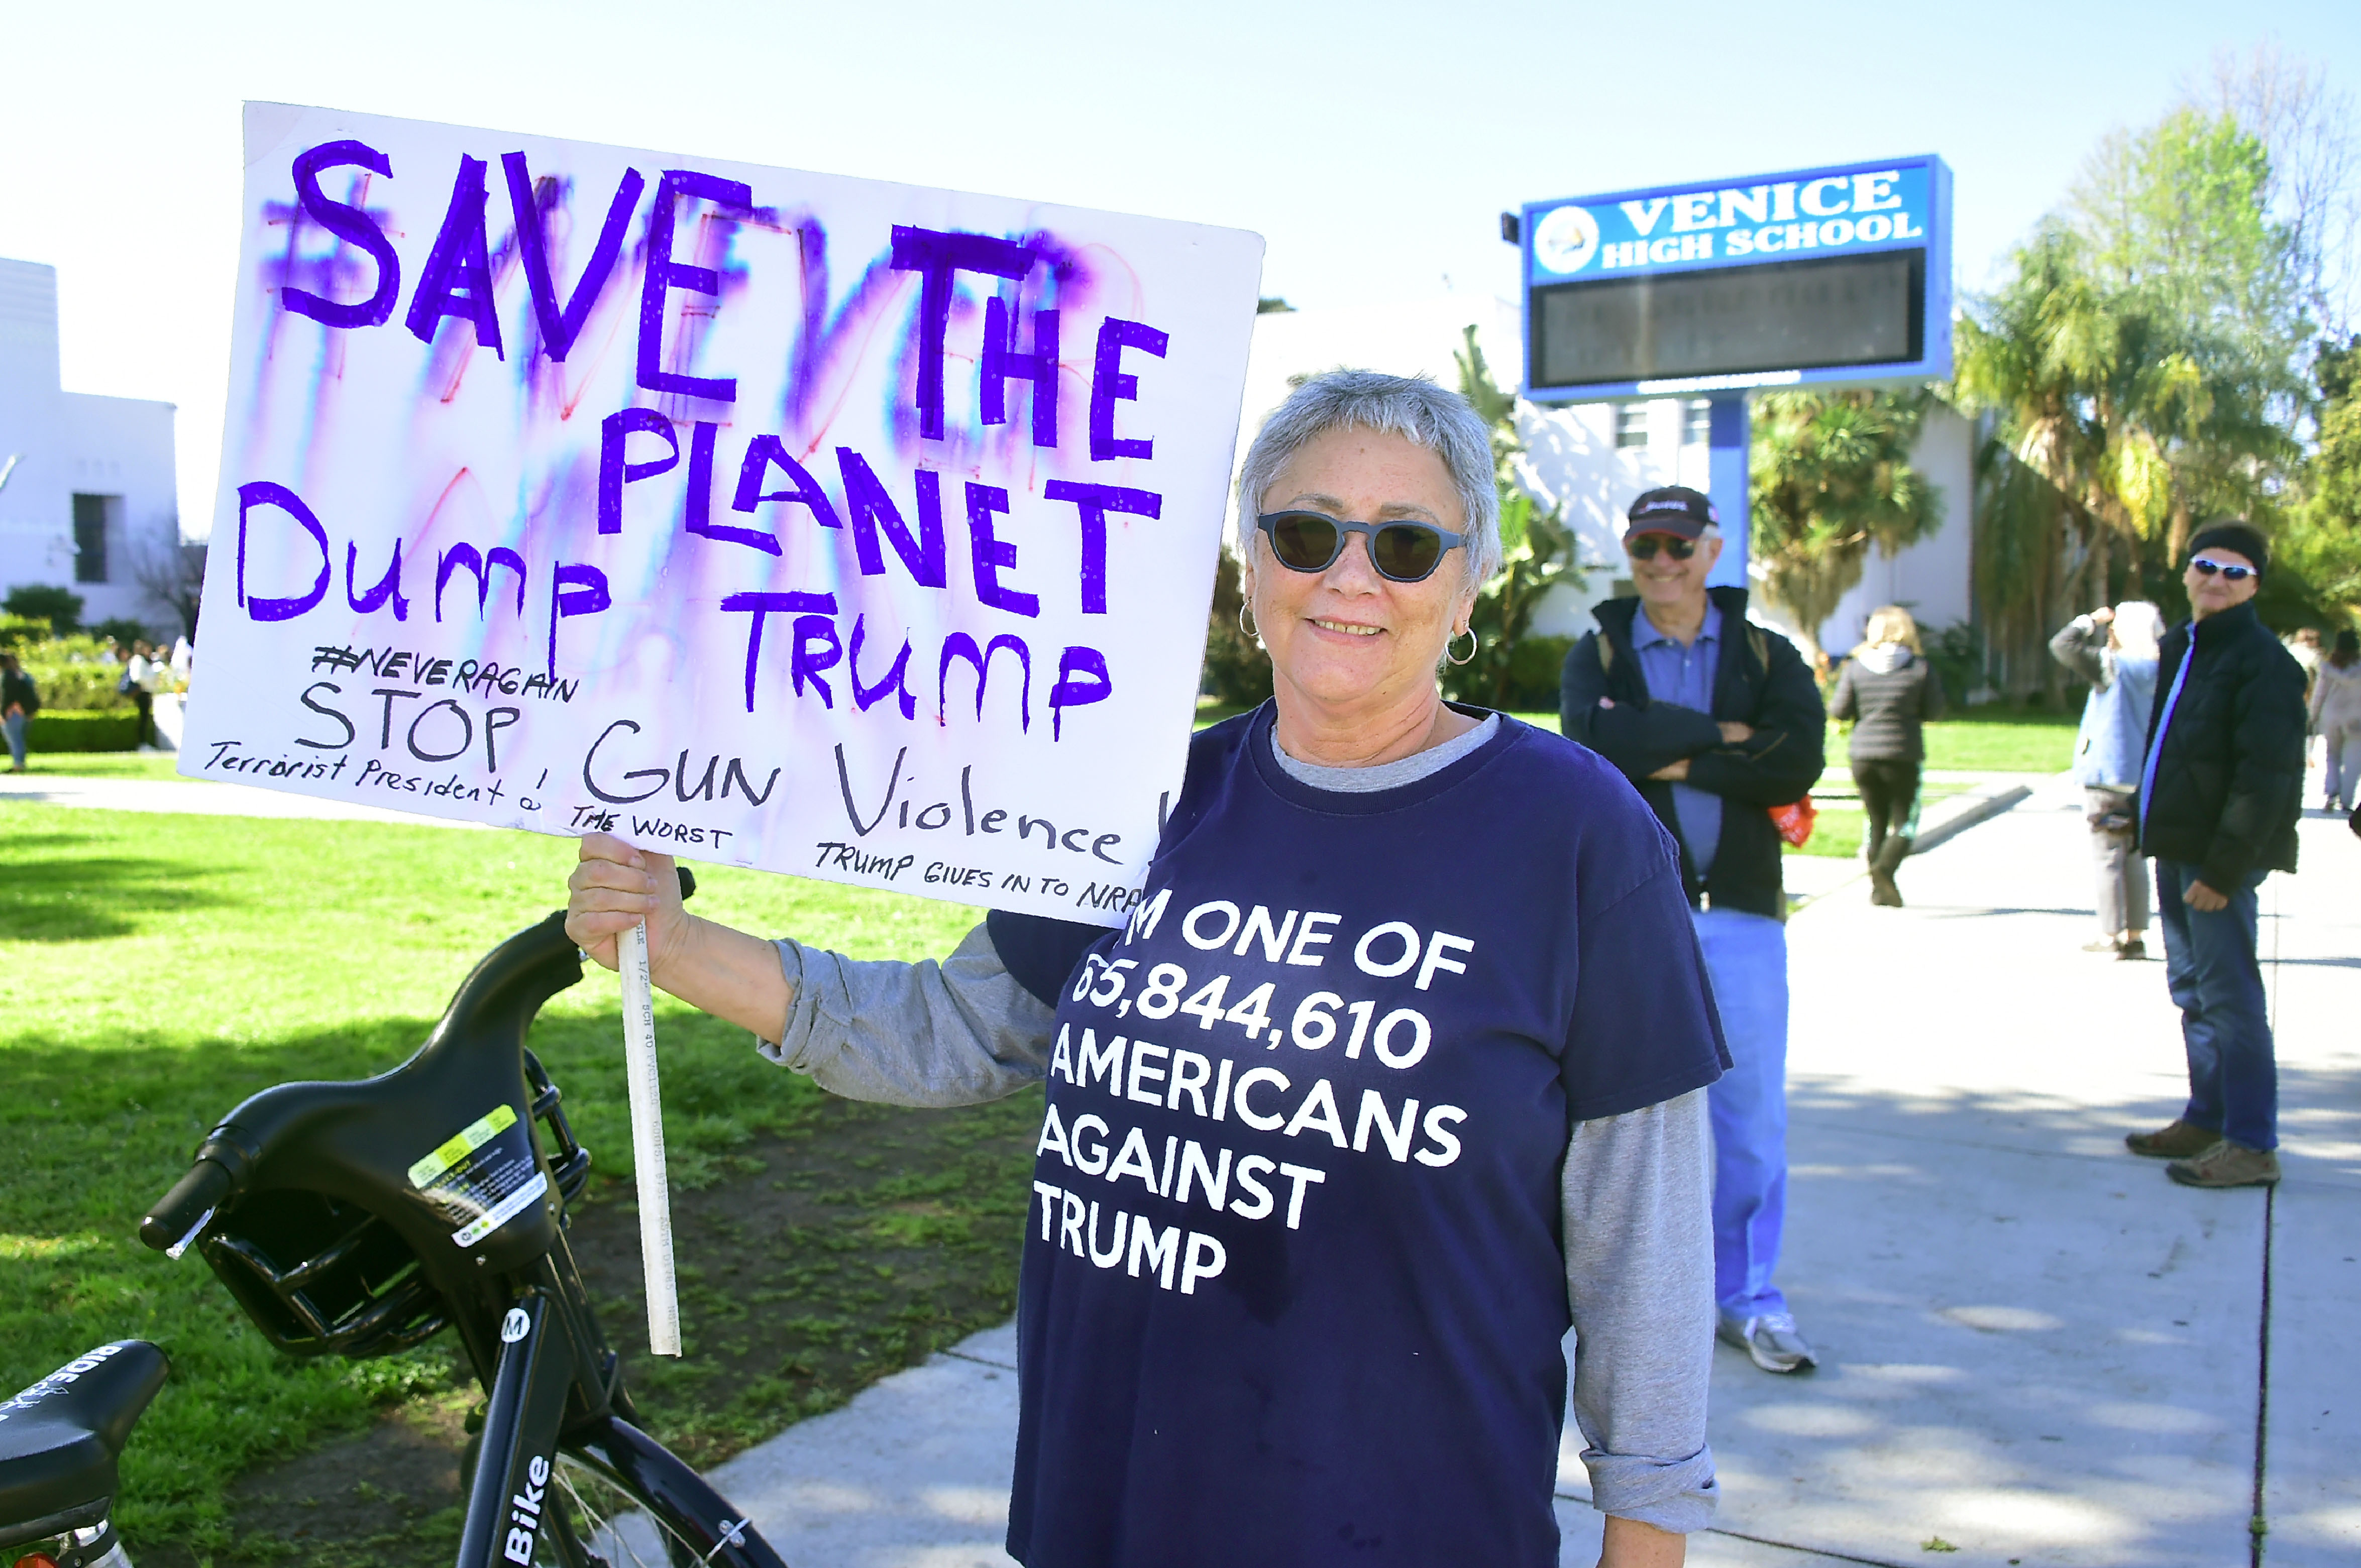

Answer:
[0,1339,170,1549]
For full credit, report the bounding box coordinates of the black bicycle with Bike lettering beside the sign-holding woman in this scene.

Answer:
[0,874,786,1568]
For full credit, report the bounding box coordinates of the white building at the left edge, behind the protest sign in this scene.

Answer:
[0,260,182,637]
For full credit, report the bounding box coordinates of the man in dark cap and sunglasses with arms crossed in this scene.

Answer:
[1558,484,1828,1372]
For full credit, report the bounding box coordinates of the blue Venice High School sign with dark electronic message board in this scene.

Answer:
[1521,156,1950,401]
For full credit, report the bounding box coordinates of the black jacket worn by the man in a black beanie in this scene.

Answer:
[2139,605,2309,892]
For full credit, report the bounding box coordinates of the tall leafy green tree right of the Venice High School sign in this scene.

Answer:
[1953,106,2314,692]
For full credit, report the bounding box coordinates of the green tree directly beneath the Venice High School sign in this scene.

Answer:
[1750,387,1943,656]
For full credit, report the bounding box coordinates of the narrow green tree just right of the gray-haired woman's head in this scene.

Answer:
[1443,326,1582,709]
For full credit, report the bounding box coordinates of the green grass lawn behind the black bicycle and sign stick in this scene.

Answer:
[0,812,1015,1561]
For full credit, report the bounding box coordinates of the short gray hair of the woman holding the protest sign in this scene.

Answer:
[1237,371,1501,586]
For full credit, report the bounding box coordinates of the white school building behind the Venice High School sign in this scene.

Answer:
[1240,293,1974,656]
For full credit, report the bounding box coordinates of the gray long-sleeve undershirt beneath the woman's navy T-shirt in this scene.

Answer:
[758,718,1719,1532]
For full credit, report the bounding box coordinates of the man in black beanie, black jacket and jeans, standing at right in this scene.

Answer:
[2125,522,2307,1188]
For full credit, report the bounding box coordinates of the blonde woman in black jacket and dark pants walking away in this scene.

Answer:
[1828,605,1943,909]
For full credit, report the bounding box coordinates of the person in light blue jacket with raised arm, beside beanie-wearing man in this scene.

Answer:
[2050,600,2165,959]
